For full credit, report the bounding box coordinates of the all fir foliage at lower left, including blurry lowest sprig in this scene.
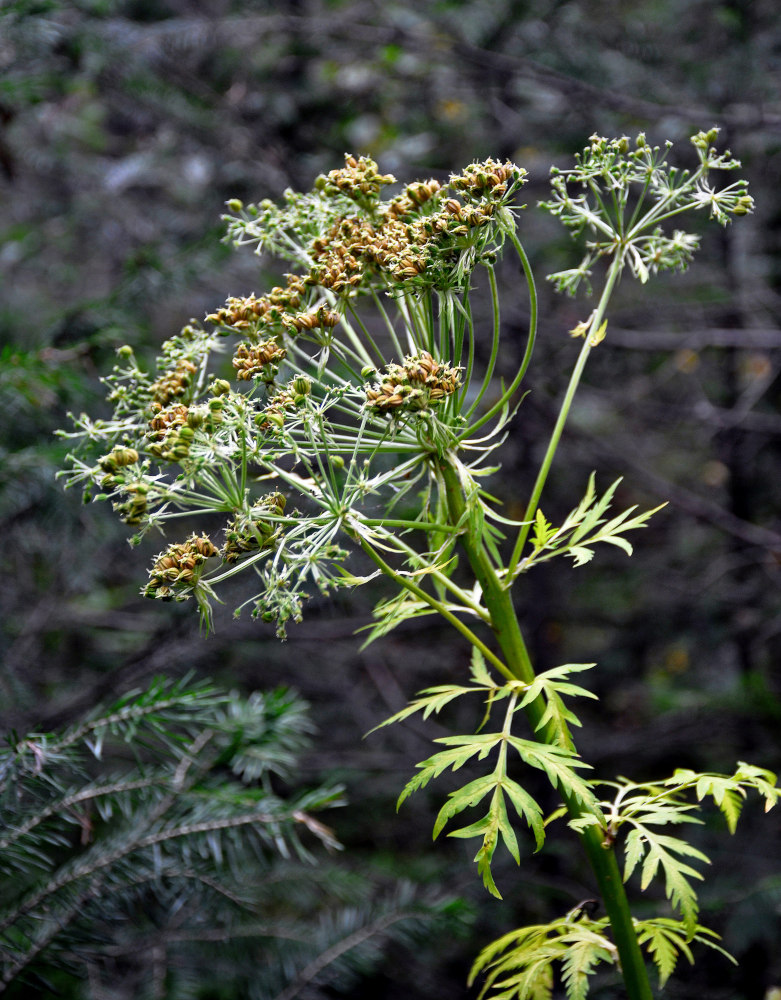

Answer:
[0,679,469,1000]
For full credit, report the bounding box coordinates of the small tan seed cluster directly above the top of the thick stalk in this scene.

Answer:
[365,351,461,414]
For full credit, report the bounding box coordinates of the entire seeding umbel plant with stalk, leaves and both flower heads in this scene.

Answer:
[61,129,779,1000]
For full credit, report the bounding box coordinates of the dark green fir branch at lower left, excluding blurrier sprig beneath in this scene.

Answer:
[0,680,341,984]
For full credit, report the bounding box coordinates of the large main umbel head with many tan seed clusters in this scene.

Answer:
[59,155,525,629]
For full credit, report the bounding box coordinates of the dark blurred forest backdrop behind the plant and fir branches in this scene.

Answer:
[0,0,781,1000]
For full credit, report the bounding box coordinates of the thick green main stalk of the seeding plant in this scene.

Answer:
[440,456,653,1000]
